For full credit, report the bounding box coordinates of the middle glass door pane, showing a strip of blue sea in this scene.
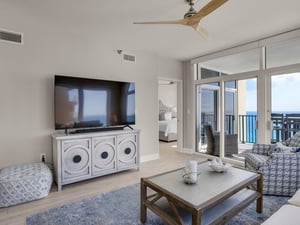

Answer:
[224,78,257,159]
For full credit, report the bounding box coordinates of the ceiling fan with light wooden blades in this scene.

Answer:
[134,0,228,38]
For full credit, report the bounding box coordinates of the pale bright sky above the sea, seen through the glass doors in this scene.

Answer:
[246,73,300,112]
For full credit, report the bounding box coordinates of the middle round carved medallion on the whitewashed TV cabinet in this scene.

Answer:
[93,143,115,168]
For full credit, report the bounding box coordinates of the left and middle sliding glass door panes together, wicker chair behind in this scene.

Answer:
[196,78,257,159]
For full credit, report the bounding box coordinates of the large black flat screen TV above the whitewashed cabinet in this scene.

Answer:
[54,75,135,130]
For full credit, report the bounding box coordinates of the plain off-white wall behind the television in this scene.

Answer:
[0,1,183,168]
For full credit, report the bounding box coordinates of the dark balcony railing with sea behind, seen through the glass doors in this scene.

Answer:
[201,113,300,143]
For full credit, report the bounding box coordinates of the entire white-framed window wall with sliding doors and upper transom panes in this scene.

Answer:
[192,30,300,160]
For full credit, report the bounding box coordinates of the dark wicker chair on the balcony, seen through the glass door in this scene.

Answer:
[204,125,238,156]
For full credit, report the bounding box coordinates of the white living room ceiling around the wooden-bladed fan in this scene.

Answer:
[12,0,300,60]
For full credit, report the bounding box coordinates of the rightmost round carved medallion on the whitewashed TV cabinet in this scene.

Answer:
[118,140,136,162]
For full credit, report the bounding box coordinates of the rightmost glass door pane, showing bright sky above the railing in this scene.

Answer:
[271,72,300,143]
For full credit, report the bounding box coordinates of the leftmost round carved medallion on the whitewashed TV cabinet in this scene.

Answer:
[63,146,89,174]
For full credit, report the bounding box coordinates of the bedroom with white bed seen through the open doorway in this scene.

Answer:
[158,79,180,154]
